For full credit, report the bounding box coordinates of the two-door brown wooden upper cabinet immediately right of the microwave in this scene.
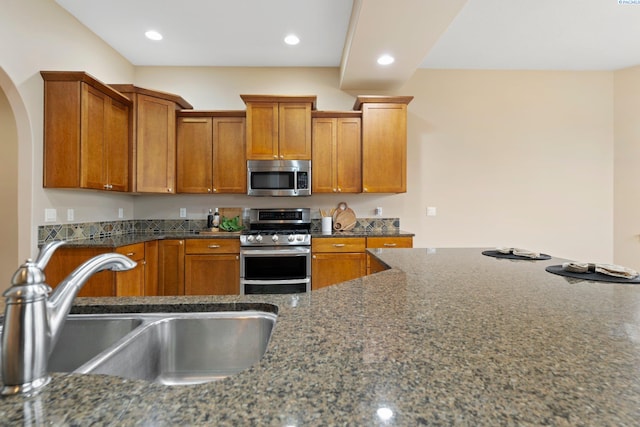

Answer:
[311,111,362,193]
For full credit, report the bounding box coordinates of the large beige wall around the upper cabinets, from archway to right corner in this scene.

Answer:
[0,0,633,276]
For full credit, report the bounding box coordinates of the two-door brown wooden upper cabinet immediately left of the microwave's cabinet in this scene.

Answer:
[177,111,247,194]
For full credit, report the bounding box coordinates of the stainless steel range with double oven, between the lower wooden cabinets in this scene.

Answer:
[240,208,311,295]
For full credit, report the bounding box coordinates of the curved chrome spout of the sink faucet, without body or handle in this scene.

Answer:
[47,253,137,356]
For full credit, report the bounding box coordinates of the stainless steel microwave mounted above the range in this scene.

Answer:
[247,160,311,197]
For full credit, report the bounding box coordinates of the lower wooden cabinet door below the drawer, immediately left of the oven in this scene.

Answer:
[185,254,240,295]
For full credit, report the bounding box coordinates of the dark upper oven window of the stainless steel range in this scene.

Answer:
[244,255,308,280]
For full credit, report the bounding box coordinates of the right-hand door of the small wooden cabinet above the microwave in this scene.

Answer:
[278,102,311,160]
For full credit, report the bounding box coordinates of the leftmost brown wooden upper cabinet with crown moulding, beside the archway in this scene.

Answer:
[40,71,131,191]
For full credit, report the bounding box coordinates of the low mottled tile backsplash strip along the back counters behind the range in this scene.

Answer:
[38,218,400,245]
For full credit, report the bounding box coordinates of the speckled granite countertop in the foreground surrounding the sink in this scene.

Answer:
[0,249,640,426]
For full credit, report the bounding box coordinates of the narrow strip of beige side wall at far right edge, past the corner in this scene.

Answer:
[614,67,640,269]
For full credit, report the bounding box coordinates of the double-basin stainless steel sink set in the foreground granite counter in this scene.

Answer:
[0,310,277,385]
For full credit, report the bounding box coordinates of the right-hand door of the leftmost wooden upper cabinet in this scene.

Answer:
[104,100,130,191]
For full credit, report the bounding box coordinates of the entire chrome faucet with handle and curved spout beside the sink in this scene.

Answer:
[0,241,136,396]
